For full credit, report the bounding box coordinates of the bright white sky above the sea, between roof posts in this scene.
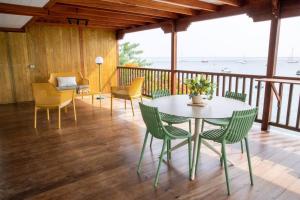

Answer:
[120,15,300,57]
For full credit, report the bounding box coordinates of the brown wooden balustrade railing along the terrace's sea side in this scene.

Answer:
[118,67,300,131]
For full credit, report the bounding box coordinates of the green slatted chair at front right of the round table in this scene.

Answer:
[196,108,257,195]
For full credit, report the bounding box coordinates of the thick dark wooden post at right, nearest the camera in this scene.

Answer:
[261,0,280,131]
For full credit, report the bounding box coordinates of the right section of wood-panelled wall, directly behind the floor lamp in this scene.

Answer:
[83,29,117,92]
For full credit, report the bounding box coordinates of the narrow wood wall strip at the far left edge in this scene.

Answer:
[0,32,14,103]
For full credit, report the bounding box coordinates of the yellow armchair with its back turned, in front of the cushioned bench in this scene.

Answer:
[32,83,77,129]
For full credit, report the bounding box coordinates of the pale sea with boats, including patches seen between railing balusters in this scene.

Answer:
[141,57,300,135]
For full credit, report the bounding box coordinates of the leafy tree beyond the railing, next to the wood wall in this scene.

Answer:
[119,42,151,67]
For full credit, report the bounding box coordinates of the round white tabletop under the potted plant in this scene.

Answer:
[145,95,251,119]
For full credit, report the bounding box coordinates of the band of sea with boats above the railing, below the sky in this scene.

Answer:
[146,57,300,78]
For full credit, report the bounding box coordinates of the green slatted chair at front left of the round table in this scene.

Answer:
[137,103,192,187]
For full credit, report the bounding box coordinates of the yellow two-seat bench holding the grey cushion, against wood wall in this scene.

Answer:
[48,72,99,104]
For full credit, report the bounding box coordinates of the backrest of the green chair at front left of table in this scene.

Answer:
[139,103,165,139]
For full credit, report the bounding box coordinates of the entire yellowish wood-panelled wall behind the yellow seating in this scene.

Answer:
[0,25,117,103]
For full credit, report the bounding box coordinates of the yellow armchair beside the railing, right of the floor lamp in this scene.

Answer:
[110,77,145,116]
